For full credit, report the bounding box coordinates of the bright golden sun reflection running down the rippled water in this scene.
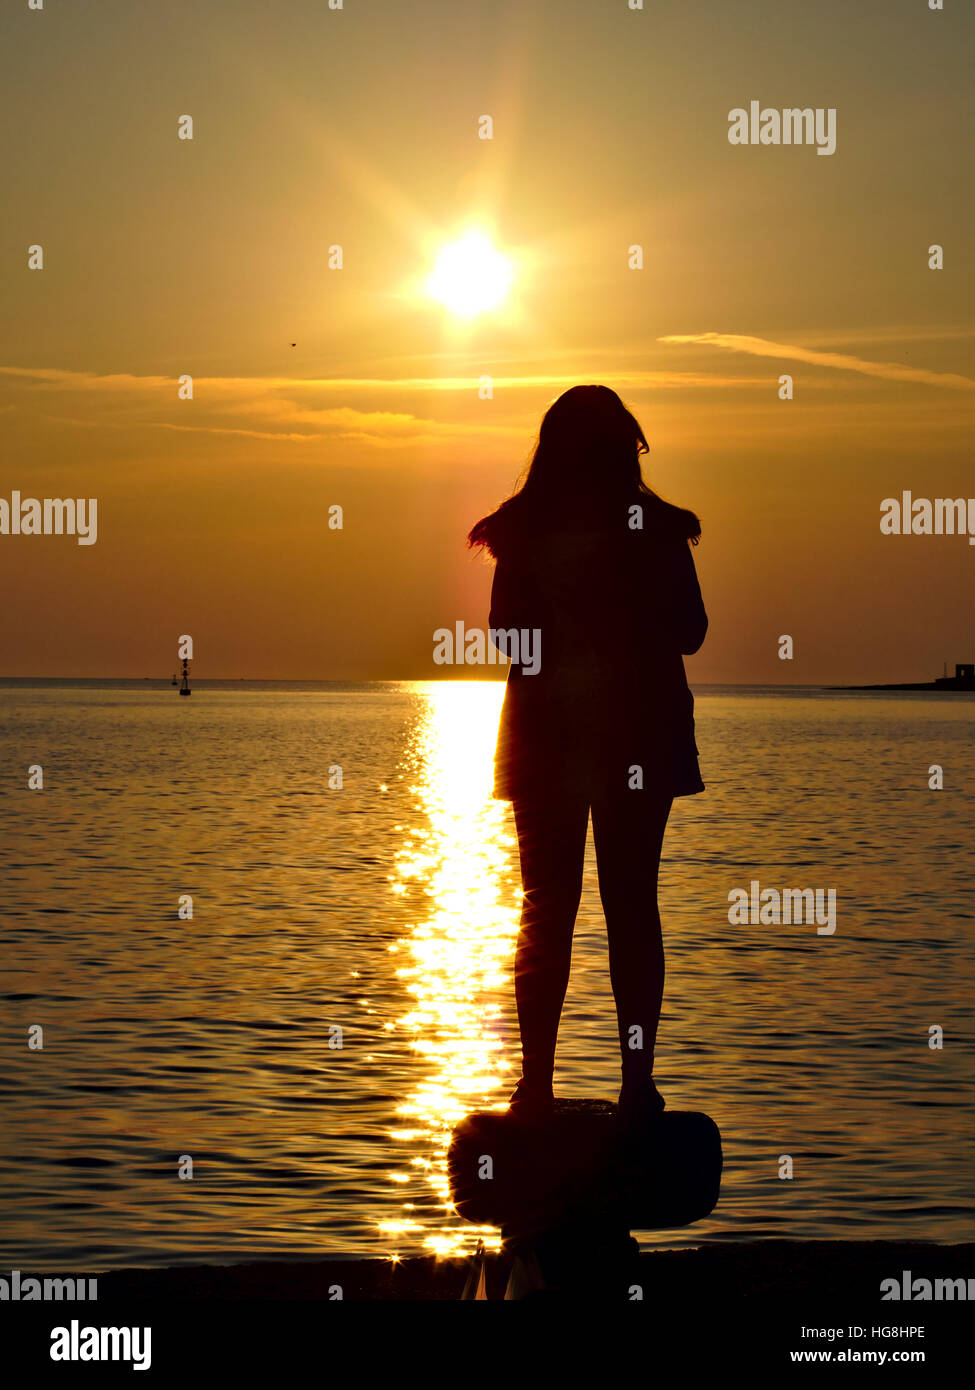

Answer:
[381,681,520,1255]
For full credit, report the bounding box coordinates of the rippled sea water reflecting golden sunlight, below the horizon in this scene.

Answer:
[0,680,975,1270]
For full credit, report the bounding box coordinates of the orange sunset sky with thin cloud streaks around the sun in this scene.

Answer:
[0,0,975,682]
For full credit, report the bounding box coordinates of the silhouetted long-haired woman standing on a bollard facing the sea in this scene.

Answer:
[467,386,708,1122]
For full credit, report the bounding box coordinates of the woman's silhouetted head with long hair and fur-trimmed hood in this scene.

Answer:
[467,386,701,559]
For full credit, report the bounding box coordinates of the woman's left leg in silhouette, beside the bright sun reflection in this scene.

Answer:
[513,795,588,1097]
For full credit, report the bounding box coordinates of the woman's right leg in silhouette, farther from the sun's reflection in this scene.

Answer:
[593,785,672,1091]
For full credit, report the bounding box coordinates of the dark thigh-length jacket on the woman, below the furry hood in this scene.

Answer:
[491,525,708,801]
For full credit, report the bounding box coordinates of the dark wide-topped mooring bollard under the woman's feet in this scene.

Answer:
[448,1101,722,1298]
